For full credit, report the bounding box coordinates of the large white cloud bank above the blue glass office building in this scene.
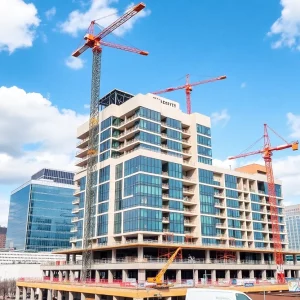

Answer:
[0,87,88,225]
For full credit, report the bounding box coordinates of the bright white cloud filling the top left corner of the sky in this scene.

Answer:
[0,0,40,53]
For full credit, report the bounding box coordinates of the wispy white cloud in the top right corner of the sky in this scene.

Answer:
[268,0,300,50]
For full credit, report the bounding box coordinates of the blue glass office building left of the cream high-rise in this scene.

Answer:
[6,169,74,252]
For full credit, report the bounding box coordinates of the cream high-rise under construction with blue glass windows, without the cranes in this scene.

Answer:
[17,90,300,300]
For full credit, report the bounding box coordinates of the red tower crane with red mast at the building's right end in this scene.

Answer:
[228,124,298,283]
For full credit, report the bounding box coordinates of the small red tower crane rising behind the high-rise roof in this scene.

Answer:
[152,74,227,115]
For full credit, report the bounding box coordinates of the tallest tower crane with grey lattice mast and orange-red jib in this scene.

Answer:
[72,2,148,281]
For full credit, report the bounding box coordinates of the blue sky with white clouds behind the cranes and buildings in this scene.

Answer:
[0,0,300,225]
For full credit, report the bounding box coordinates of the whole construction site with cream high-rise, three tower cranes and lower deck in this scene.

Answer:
[16,3,300,300]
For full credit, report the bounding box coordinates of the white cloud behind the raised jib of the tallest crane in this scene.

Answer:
[59,0,150,36]
